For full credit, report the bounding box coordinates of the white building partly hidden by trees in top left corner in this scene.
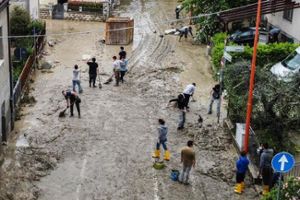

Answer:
[9,0,40,19]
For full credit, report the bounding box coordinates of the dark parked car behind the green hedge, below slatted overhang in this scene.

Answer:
[228,27,267,46]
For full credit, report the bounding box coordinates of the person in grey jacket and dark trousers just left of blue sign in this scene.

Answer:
[259,143,273,195]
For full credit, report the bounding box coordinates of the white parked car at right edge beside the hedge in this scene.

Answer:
[271,47,300,82]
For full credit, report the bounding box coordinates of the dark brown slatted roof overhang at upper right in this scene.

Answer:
[219,0,300,23]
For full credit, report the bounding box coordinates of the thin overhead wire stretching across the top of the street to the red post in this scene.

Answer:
[0,3,257,39]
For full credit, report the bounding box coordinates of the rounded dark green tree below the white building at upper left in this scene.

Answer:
[10,6,31,35]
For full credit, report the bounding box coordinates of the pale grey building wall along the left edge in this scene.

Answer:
[0,0,12,144]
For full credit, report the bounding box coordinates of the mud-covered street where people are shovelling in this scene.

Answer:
[0,0,257,200]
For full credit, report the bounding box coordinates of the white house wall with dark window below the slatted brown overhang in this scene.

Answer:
[266,0,300,43]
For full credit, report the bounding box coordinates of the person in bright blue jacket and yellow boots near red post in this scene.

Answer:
[234,151,249,194]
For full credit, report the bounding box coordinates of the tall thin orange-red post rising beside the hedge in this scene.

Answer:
[244,0,261,152]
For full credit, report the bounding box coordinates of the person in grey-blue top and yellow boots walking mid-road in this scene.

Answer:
[152,119,170,161]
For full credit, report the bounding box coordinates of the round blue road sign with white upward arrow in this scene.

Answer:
[272,152,295,173]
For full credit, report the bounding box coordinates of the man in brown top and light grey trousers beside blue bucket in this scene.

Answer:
[178,140,196,185]
